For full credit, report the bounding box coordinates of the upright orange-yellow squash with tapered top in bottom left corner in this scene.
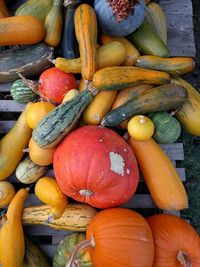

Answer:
[0,188,28,267]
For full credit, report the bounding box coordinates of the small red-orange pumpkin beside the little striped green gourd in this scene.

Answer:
[38,67,78,104]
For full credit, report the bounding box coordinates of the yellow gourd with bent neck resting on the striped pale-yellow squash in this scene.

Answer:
[35,176,68,219]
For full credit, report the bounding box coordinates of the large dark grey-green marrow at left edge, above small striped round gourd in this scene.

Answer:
[0,42,52,82]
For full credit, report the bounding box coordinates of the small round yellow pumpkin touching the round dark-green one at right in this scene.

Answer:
[127,115,154,141]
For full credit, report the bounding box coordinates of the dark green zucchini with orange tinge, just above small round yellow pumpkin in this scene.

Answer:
[101,84,188,126]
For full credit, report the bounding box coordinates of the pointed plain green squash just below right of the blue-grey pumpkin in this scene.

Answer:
[127,20,169,57]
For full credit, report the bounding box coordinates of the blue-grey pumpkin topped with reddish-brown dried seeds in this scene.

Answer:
[94,0,146,37]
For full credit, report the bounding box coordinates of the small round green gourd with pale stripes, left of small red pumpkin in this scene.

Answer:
[10,79,39,104]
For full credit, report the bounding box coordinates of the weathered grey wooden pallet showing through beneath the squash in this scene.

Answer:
[0,0,195,259]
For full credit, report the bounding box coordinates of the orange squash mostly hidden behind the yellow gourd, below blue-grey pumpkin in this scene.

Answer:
[100,33,140,66]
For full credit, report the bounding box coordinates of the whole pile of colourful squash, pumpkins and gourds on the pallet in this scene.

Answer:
[0,0,200,267]
